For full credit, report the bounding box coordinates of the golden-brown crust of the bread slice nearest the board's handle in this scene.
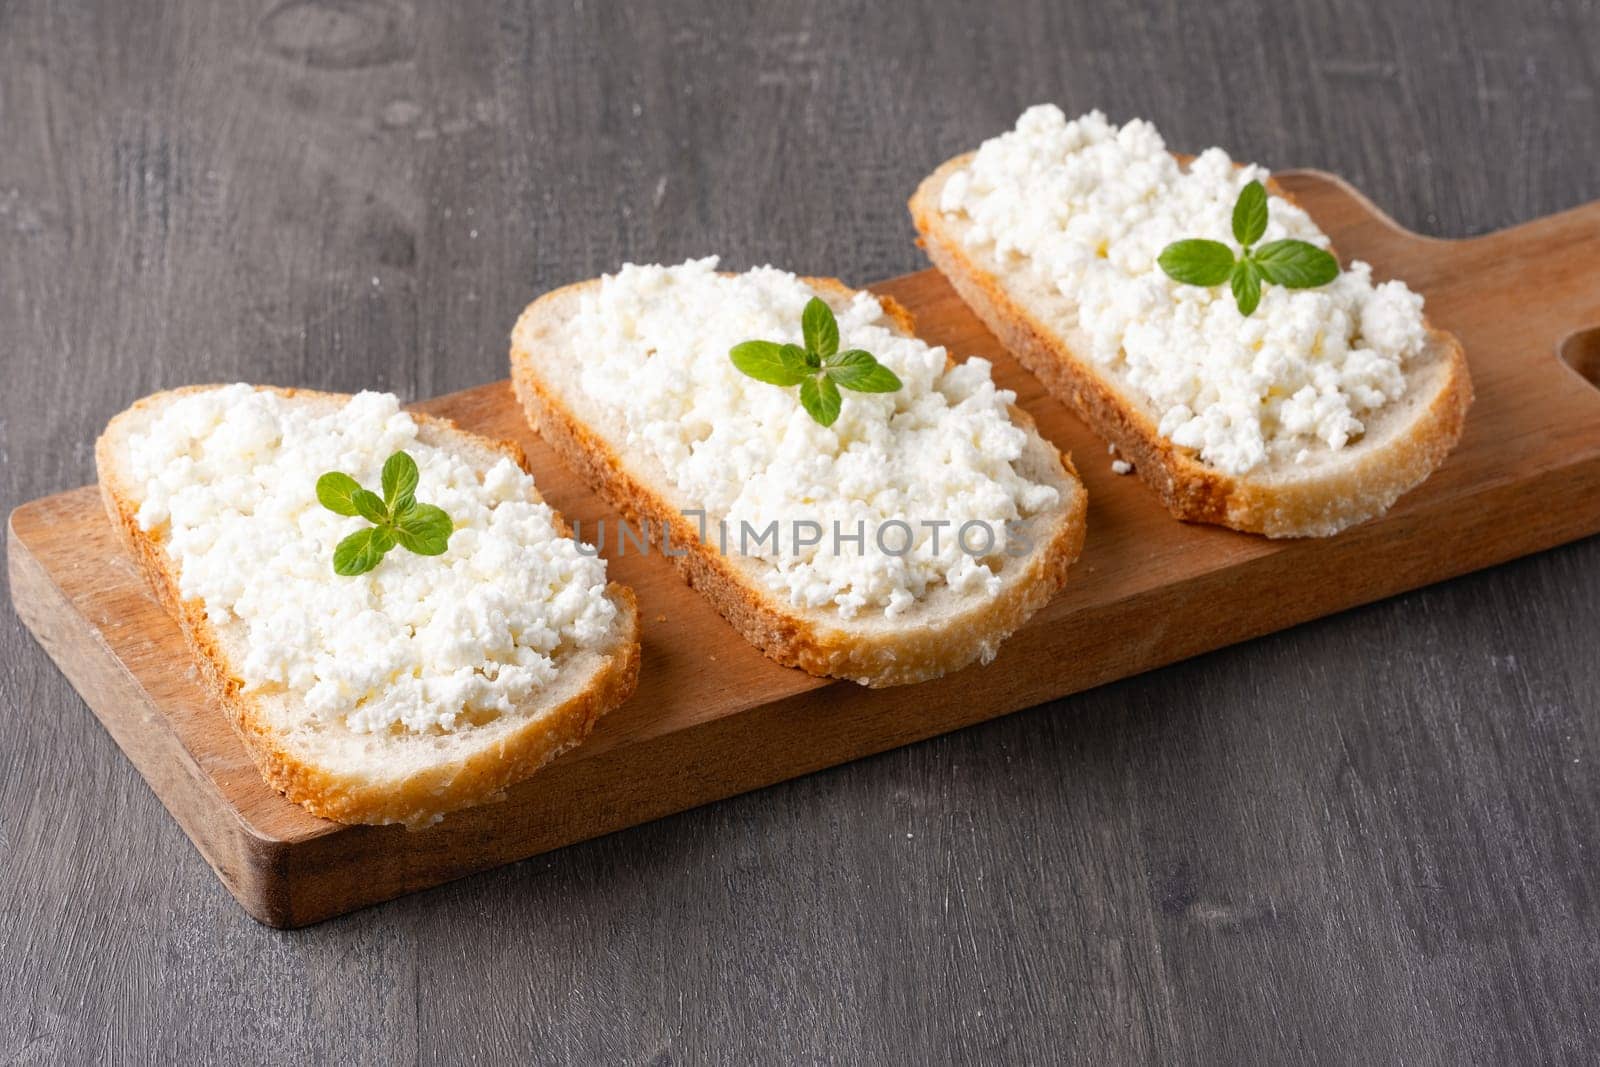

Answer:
[909,154,1472,537]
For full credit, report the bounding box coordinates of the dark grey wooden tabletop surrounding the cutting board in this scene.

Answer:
[0,0,1600,1064]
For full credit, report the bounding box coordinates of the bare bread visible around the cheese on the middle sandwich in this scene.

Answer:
[510,278,1086,688]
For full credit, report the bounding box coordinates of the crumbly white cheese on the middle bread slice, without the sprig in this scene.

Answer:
[574,258,1056,617]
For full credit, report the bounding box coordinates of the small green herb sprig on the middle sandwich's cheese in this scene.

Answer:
[728,296,901,426]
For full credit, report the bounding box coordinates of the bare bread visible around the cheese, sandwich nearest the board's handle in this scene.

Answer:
[910,154,1472,537]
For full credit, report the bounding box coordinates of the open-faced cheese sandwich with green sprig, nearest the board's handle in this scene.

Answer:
[910,106,1472,537]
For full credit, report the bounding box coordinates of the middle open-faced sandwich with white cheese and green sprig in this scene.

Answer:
[512,259,1085,686]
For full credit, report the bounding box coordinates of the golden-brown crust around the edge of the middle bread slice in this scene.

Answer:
[510,278,1086,688]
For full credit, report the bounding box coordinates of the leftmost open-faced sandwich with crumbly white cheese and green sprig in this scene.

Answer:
[94,386,638,827]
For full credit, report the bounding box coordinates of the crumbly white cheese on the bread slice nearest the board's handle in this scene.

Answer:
[939,104,1426,474]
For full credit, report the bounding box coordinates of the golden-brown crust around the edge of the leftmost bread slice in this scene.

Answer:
[94,386,640,829]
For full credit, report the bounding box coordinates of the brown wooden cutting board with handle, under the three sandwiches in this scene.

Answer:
[8,171,1600,926]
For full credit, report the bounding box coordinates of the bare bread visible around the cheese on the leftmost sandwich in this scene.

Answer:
[94,386,638,829]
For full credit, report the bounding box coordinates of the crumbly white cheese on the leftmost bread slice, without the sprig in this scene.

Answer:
[130,386,616,733]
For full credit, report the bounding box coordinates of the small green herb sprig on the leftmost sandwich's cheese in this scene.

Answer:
[317,453,456,577]
